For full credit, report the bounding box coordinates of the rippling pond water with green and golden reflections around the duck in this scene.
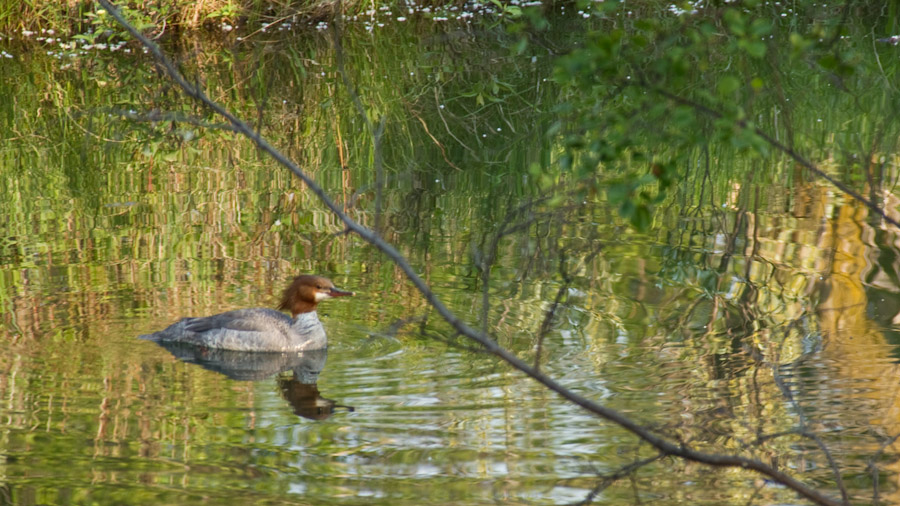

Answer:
[0,6,900,505]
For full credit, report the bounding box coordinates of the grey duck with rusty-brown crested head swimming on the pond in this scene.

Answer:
[140,274,355,352]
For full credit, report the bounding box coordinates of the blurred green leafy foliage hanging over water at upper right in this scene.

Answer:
[517,0,900,229]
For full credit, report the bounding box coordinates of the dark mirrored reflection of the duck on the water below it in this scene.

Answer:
[148,342,353,420]
